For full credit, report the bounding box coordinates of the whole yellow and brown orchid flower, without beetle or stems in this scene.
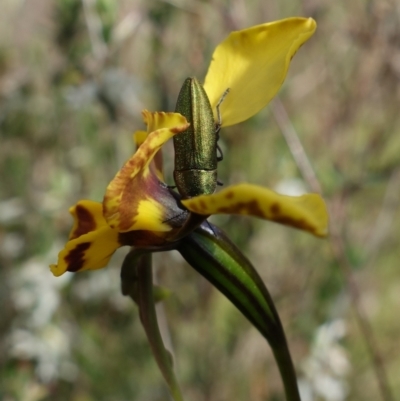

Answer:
[50,18,328,276]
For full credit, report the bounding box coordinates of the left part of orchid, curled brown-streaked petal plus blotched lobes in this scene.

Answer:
[50,110,189,276]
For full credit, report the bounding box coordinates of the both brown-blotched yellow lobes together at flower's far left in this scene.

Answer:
[50,200,122,276]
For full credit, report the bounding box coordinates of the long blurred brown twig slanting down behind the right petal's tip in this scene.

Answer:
[272,100,397,401]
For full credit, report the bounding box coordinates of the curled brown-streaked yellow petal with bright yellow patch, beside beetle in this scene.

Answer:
[103,111,189,232]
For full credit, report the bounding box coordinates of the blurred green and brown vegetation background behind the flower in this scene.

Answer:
[0,0,400,401]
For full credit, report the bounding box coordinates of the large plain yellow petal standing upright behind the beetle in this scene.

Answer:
[204,18,316,126]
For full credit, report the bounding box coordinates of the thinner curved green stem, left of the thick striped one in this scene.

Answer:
[137,253,183,401]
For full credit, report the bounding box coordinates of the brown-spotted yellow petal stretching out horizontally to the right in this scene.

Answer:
[182,184,328,237]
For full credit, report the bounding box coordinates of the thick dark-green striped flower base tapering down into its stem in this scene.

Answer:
[177,221,300,401]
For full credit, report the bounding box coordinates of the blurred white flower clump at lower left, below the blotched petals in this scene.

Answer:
[7,259,78,383]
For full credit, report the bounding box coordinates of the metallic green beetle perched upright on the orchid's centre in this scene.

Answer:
[174,78,220,199]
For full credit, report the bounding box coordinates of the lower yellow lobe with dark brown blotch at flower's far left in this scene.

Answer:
[50,224,122,277]
